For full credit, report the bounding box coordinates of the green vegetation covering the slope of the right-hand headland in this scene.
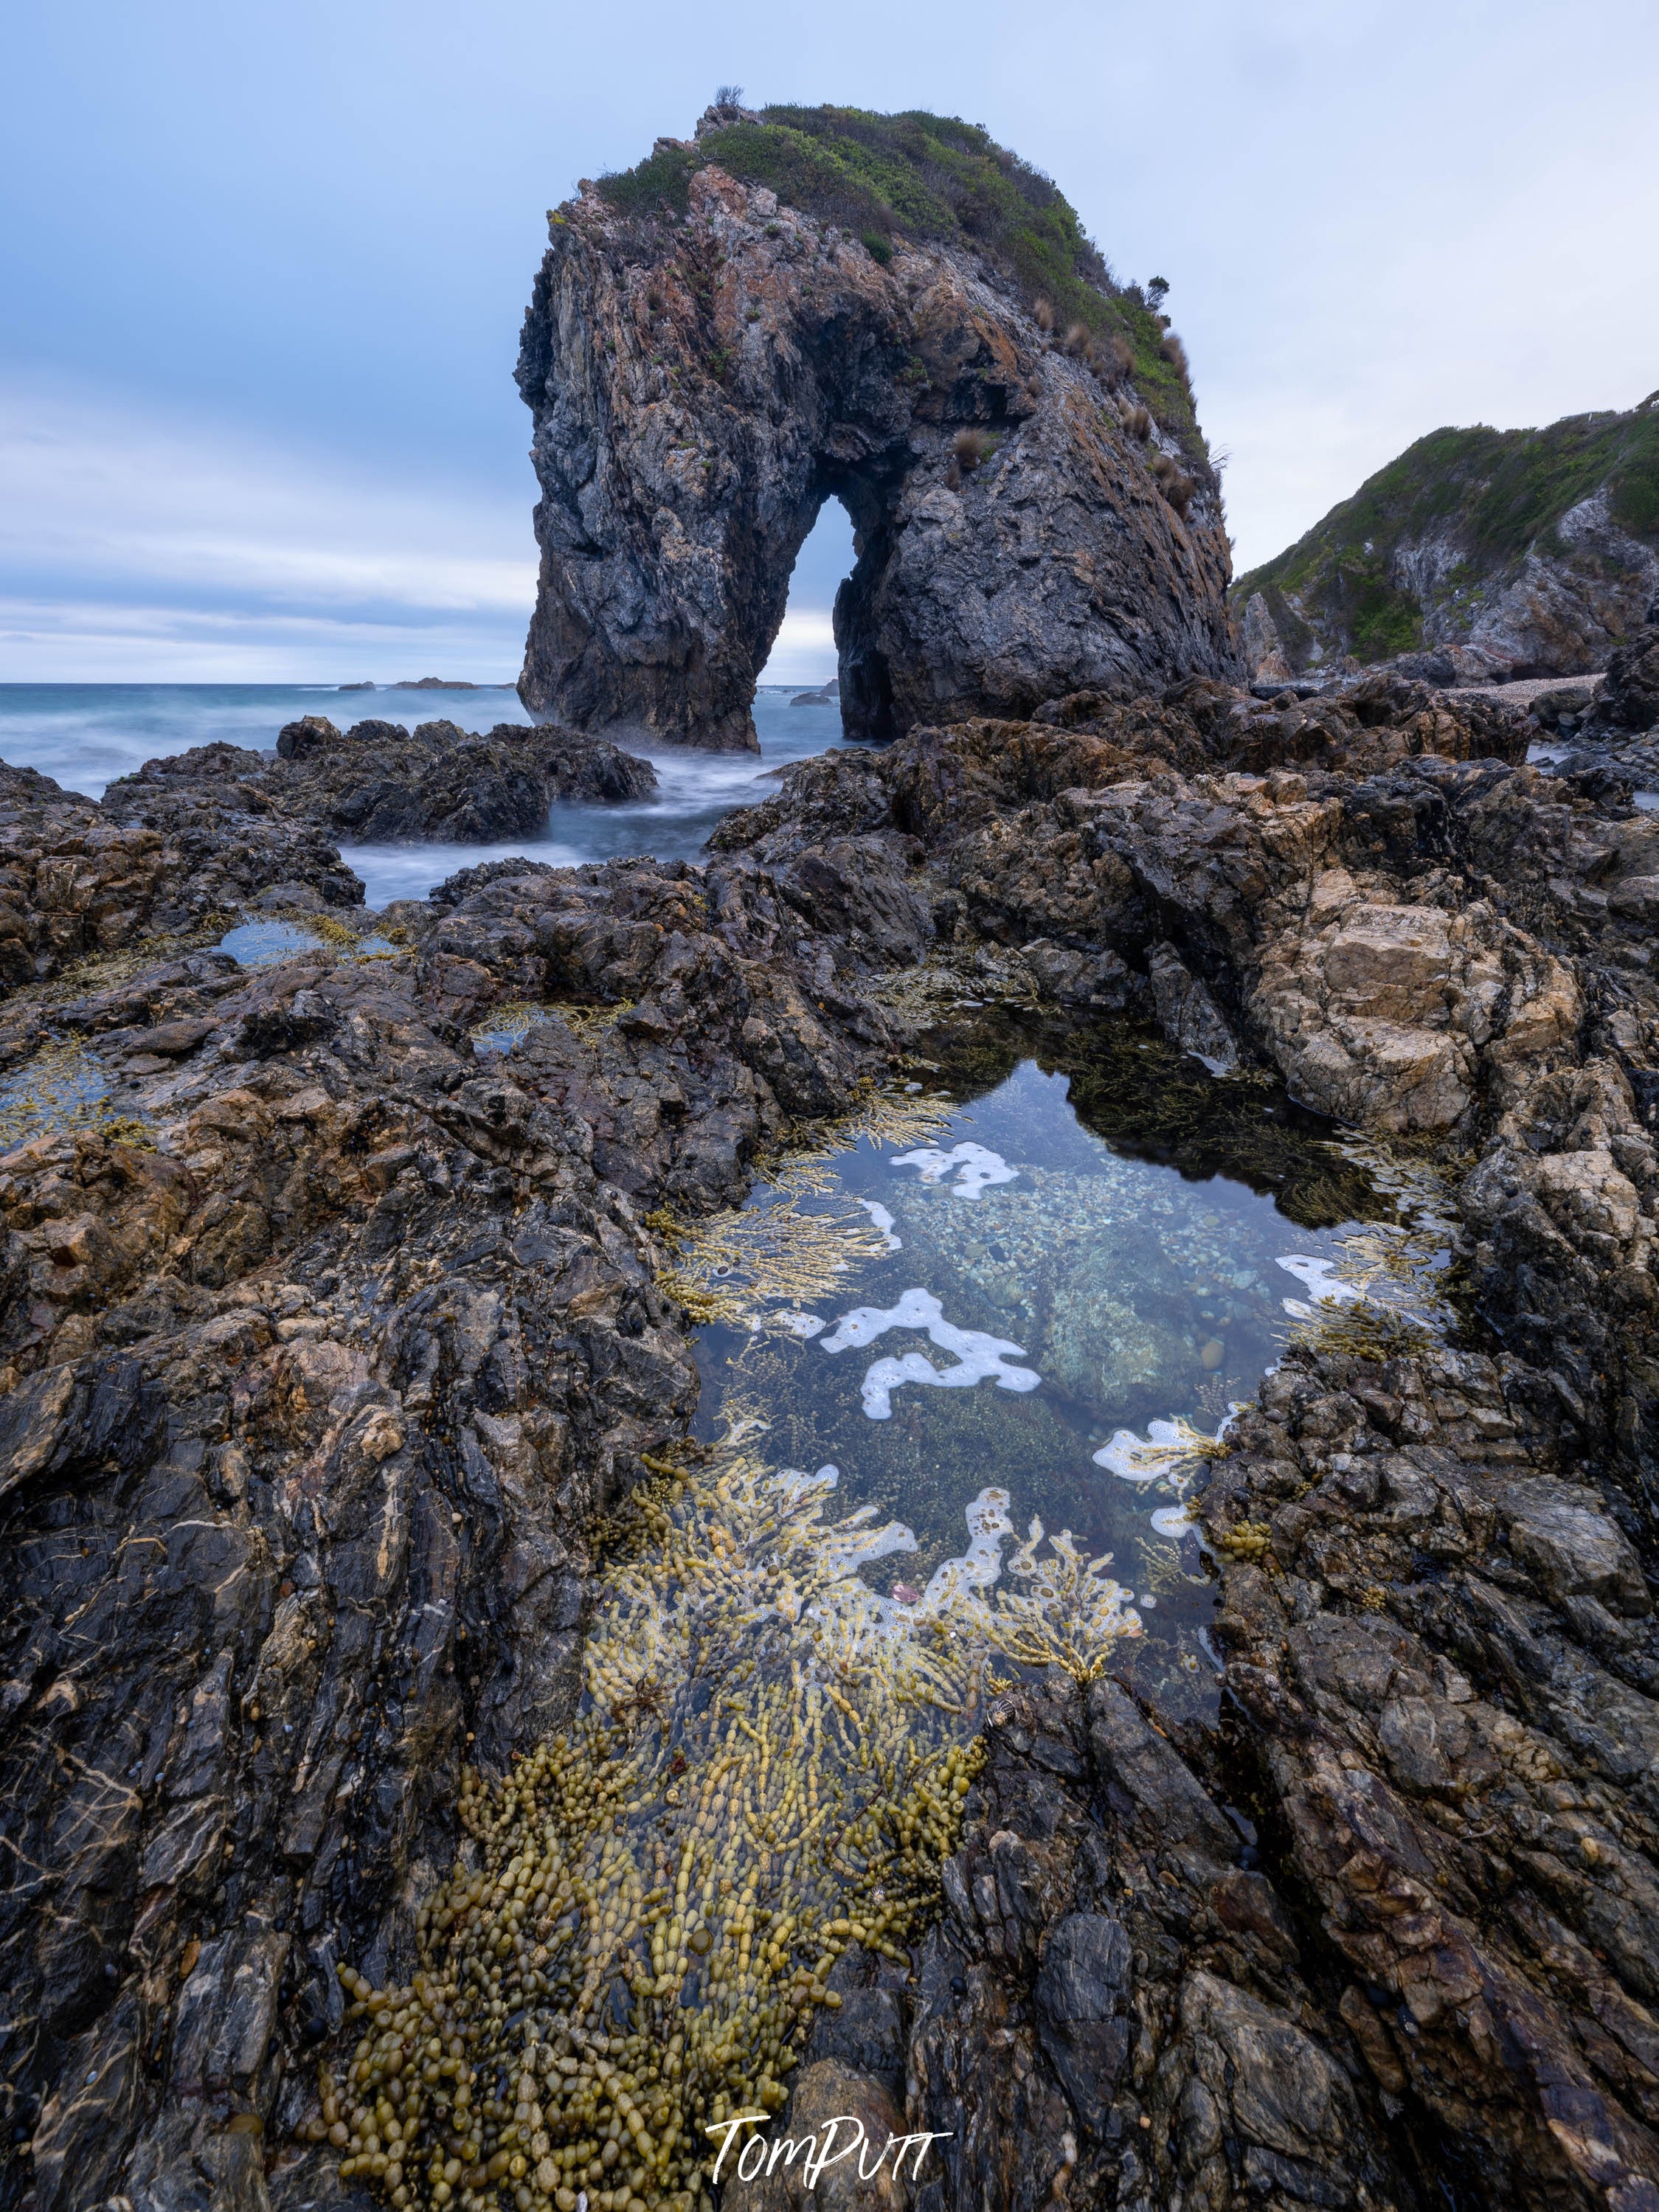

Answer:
[1232,394,1659,668]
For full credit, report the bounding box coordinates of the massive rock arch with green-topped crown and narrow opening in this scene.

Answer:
[518,106,1234,750]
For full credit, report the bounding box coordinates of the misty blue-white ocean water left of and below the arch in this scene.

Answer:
[0,684,840,907]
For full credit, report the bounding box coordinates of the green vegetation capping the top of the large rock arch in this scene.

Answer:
[600,106,1208,460]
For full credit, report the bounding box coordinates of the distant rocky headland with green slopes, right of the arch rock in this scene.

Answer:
[1232,392,1659,684]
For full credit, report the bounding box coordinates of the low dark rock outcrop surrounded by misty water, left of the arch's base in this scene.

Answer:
[106,715,657,845]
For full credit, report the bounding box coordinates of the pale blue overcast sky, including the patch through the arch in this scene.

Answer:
[0,0,1659,682]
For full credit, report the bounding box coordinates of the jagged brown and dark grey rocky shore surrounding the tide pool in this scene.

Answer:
[0,659,1659,2212]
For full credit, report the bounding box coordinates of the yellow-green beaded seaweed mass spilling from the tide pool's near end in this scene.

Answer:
[320,1446,1139,2212]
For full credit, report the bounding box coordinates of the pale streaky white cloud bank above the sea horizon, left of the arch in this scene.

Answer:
[0,385,536,682]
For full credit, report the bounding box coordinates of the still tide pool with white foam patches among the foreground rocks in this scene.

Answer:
[684,1033,1442,1712]
